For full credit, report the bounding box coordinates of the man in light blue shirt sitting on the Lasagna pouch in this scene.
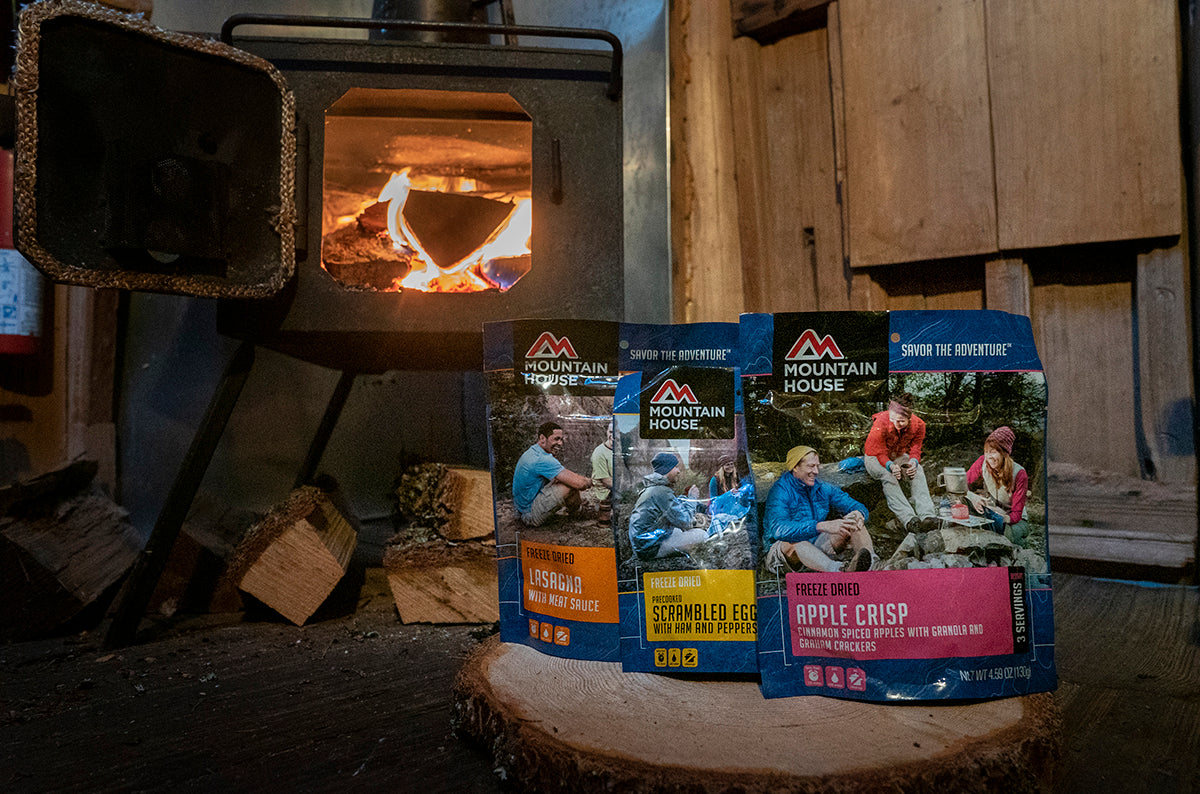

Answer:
[512,422,592,527]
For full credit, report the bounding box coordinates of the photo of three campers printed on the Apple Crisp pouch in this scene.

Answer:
[746,372,1049,578]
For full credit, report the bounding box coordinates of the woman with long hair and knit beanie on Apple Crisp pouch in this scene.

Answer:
[967,426,1030,546]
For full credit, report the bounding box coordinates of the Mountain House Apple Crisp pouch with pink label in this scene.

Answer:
[739,311,1057,702]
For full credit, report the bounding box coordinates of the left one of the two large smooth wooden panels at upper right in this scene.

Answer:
[829,0,996,266]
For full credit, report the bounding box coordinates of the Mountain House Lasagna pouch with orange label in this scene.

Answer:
[484,320,620,661]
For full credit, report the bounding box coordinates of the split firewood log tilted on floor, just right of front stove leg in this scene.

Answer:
[226,486,358,626]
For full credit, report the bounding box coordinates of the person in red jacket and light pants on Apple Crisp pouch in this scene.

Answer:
[863,392,938,533]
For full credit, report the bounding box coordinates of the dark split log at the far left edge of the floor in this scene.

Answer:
[0,461,142,640]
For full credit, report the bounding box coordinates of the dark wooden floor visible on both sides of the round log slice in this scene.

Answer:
[0,570,1200,794]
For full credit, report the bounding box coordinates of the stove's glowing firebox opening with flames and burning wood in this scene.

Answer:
[322,89,533,293]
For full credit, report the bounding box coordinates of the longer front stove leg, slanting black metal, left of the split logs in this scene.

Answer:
[104,342,254,648]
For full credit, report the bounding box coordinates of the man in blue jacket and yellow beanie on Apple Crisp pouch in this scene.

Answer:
[762,446,876,575]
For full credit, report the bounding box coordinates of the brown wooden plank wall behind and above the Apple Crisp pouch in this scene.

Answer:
[671,0,1196,573]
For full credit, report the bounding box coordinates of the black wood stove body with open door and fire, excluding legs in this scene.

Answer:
[14,0,624,372]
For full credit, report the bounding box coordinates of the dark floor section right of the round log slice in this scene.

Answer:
[1054,573,1200,792]
